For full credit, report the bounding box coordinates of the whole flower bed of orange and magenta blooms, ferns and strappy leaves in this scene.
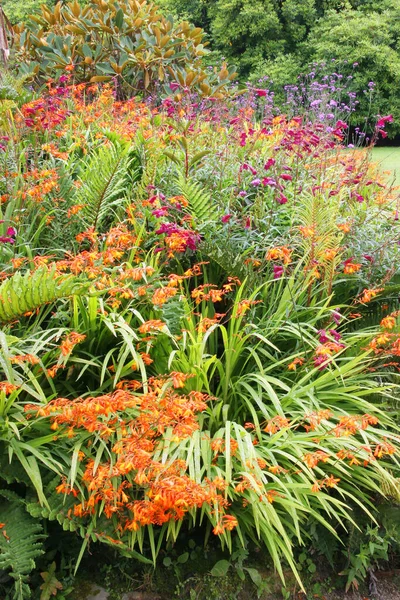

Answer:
[0,29,400,598]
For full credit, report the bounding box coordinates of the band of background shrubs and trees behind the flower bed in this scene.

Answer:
[3,0,400,137]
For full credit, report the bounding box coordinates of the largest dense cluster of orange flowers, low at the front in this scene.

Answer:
[25,372,237,535]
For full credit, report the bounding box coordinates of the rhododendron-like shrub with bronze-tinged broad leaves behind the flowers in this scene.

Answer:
[10,0,235,96]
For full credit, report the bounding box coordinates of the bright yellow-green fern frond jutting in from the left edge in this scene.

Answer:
[0,267,89,323]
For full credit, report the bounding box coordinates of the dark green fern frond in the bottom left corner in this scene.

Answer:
[0,502,43,600]
